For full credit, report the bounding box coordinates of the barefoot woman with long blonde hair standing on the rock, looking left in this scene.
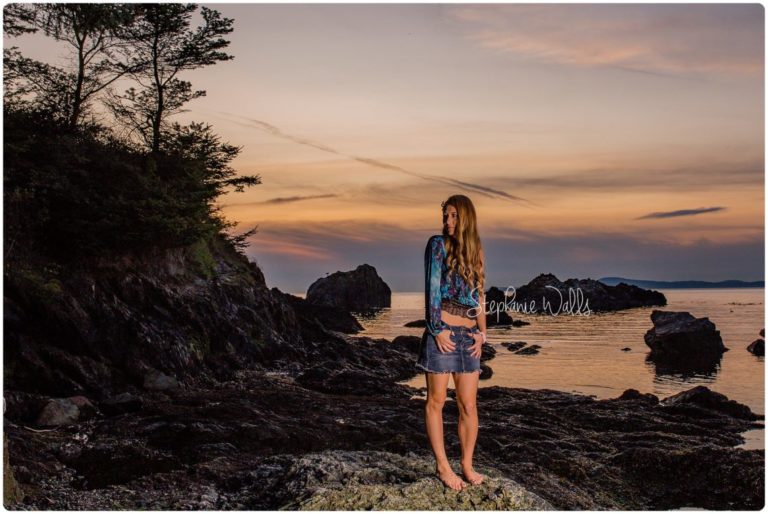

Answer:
[416,195,486,490]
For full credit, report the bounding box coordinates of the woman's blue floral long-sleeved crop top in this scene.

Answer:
[424,235,480,336]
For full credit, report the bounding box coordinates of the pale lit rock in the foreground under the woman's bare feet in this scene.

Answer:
[246,451,555,511]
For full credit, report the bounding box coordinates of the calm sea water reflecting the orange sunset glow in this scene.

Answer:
[352,289,765,448]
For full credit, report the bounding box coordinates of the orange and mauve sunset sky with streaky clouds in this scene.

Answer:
[9,4,765,293]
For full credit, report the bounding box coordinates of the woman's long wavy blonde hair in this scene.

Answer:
[441,195,485,294]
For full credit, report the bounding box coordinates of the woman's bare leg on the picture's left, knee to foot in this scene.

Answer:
[424,372,468,491]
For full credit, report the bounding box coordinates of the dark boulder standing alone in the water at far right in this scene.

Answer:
[644,309,727,364]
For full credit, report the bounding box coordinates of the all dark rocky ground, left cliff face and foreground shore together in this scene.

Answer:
[4,236,765,510]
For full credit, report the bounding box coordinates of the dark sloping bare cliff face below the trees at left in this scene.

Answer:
[4,232,332,404]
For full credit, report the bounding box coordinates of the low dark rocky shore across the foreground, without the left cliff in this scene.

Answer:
[5,364,764,510]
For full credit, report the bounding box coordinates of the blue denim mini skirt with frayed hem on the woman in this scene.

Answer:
[416,325,480,373]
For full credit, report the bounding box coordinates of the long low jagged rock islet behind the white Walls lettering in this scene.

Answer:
[509,273,667,315]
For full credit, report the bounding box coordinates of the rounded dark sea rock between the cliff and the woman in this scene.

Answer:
[307,264,392,312]
